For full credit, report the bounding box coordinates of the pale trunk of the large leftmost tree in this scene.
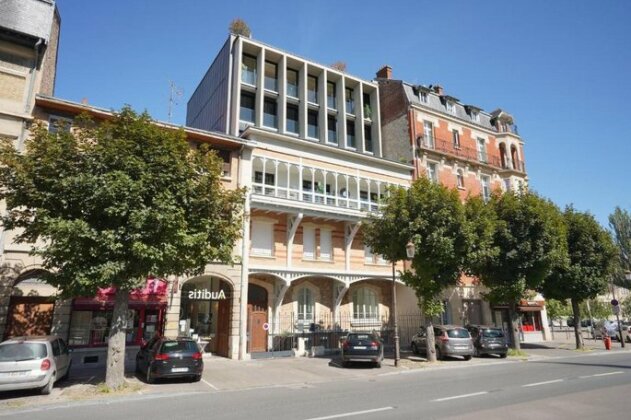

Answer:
[105,289,129,389]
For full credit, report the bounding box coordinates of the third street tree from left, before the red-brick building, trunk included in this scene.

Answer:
[468,192,566,349]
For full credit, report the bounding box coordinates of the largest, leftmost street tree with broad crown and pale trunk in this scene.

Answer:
[0,107,243,388]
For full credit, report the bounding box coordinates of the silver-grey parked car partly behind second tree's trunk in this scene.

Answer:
[410,325,474,360]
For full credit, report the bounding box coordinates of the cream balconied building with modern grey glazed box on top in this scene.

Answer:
[187,35,418,358]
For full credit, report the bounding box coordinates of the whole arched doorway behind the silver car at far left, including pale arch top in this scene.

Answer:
[3,270,57,340]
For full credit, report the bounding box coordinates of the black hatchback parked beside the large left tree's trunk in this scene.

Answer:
[136,337,204,383]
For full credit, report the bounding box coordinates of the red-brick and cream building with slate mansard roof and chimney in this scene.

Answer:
[376,66,550,341]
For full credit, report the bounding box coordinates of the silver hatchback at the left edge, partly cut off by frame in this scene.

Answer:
[0,335,72,395]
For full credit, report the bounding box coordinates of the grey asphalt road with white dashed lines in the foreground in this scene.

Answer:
[0,353,631,420]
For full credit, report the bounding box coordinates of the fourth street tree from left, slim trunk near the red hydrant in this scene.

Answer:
[542,206,617,349]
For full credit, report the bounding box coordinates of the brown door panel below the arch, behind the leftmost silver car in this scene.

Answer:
[4,296,55,339]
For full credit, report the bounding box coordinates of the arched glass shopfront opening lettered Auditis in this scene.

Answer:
[180,276,232,357]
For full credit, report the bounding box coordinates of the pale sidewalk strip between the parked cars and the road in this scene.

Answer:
[0,337,631,412]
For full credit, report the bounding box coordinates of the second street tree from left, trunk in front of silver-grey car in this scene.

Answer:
[363,177,470,361]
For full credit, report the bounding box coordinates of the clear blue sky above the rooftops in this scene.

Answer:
[55,0,631,225]
